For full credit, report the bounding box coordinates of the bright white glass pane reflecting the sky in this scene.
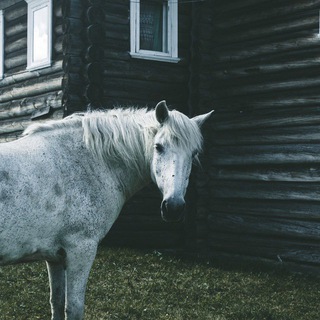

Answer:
[32,7,49,62]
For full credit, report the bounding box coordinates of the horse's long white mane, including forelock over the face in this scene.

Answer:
[24,108,202,178]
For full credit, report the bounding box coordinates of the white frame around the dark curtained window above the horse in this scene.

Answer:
[130,0,180,62]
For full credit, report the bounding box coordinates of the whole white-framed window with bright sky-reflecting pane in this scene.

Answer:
[26,0,52,70]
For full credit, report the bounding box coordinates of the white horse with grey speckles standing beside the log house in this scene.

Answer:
[0,101,211,320]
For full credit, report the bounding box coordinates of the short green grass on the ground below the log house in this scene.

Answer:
[0,248,320,320]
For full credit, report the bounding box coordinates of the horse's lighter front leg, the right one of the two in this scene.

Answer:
[66,241,97,320]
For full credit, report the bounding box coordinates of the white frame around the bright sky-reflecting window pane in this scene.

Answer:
[25,0,52,71]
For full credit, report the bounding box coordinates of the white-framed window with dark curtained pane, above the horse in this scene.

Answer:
[130,0,180,62]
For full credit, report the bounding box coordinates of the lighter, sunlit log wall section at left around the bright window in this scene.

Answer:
[0,0,63,142]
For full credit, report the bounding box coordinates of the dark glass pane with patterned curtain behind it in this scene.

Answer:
[140,0,168,52]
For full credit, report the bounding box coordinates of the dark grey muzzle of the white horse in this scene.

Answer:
[161,198,186,222]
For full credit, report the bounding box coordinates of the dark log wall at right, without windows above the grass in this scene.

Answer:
[206,0,320,267]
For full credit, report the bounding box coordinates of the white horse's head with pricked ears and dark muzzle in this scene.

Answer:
[151,101,212,221]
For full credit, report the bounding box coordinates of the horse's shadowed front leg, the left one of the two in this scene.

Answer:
[47,261,66,320]
